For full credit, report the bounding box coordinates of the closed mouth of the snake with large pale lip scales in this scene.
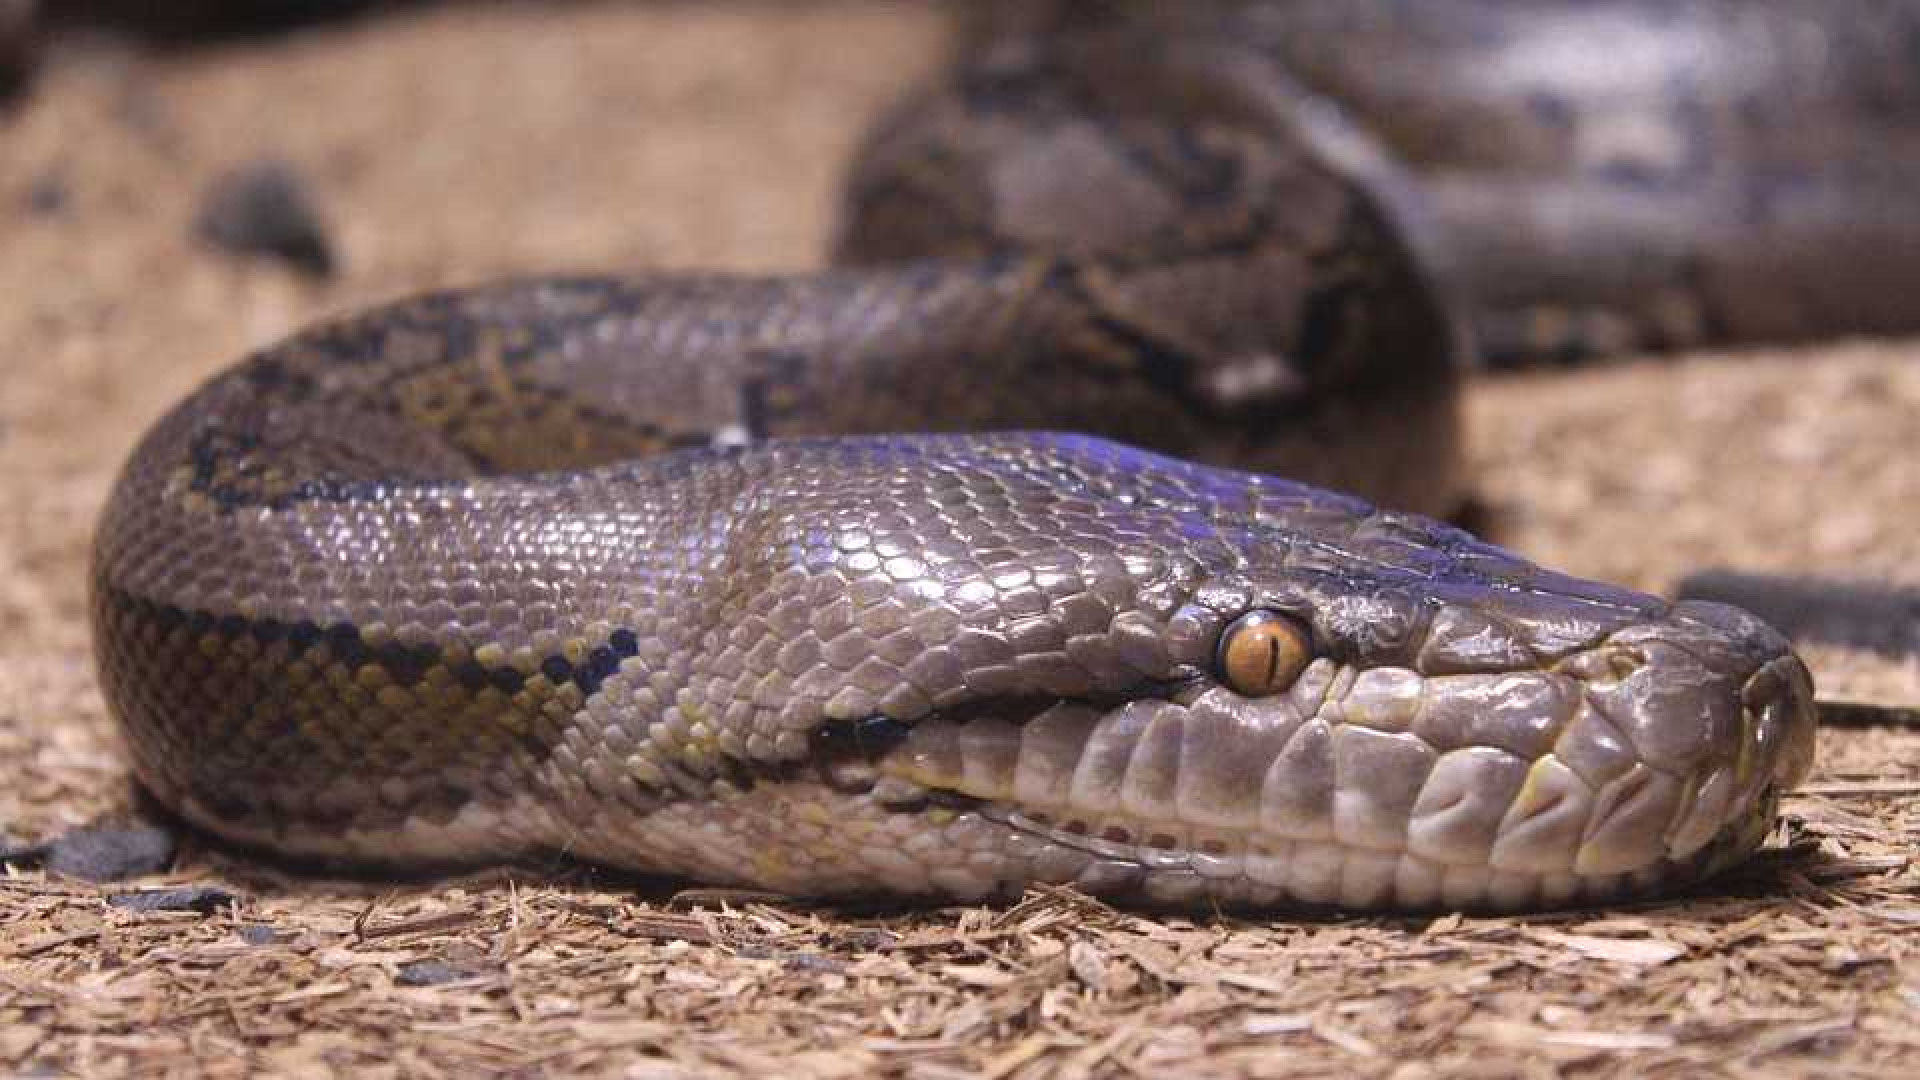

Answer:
[828,646,1812,909]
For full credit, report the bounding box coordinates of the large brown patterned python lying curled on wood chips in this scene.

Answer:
[90,0,1920,911]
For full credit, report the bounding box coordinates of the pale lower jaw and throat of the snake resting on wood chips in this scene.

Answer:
[495,776,1772,913]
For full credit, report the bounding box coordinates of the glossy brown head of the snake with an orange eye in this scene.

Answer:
[618,436,1812,909]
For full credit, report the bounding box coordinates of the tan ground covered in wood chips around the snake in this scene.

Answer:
[0,2,1920,1080]
